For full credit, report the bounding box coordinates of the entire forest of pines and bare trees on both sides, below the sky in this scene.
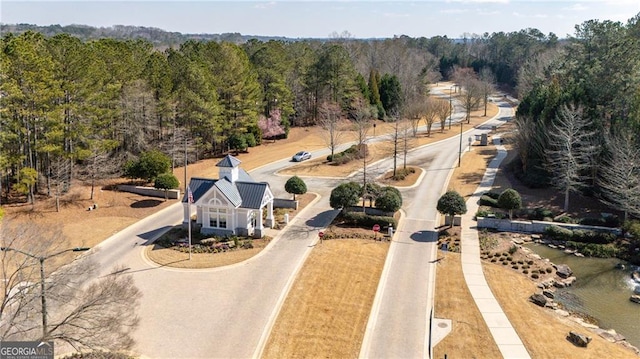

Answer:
[0,16,640,219]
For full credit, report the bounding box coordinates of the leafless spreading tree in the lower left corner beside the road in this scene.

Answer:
[0,222,140,350]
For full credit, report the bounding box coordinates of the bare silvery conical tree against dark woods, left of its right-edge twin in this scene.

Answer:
[546,105,595,212]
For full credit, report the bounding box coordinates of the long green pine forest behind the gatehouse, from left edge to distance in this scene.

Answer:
[0,17,624,208]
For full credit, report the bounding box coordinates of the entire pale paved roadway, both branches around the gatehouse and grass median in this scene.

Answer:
[79,85,511,358]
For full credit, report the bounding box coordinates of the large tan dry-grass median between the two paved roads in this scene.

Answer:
[263,239,389,358]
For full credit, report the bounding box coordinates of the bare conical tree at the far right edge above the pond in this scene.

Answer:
[598,131,640,221]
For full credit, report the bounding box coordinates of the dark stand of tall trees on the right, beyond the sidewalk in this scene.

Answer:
[515,14,640,219]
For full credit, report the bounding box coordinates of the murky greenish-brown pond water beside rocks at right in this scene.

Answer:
[526,244,640,348]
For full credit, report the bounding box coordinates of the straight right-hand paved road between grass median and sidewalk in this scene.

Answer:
[360,88,512,358]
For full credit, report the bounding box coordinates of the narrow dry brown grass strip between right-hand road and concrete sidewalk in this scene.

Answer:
[433,252,501,358]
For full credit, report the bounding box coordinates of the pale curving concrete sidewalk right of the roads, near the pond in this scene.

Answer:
[461,136,530,358]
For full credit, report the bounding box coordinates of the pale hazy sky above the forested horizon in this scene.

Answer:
[0,0,640,38]
